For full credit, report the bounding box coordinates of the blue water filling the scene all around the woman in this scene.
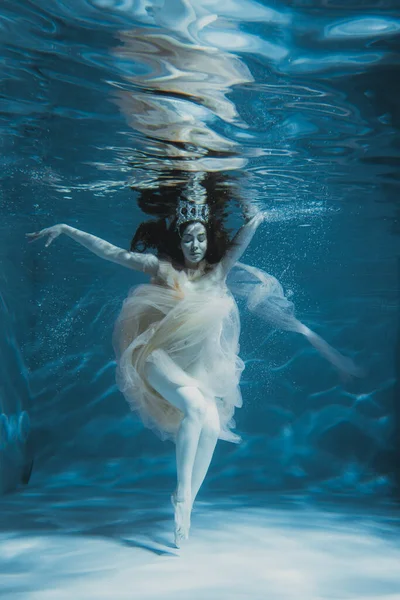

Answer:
[0,0,400,600]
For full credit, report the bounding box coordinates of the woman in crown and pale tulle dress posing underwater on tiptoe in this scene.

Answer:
[27,198,357,547]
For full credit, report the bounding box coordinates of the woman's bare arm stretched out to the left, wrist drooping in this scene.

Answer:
[26,223,158,275]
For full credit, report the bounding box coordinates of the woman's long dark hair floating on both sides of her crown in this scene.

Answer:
[130,173,245,268]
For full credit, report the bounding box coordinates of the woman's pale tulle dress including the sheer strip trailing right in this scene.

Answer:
[113,261,358,443]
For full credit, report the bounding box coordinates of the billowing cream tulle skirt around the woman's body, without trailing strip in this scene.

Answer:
[113,283,244,443]
